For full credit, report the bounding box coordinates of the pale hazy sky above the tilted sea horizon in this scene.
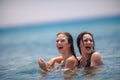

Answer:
[0,0,120,27]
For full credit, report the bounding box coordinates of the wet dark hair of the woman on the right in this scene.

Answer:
[77,32,95,55]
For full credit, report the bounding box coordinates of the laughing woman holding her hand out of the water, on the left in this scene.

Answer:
[38,32,78,71]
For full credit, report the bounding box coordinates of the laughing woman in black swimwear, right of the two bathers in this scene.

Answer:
[77,32,103,67]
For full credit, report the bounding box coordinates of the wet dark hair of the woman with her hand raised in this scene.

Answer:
[57,32,77,59]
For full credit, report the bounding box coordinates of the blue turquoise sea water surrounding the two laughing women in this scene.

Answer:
[0,17,120,80]
